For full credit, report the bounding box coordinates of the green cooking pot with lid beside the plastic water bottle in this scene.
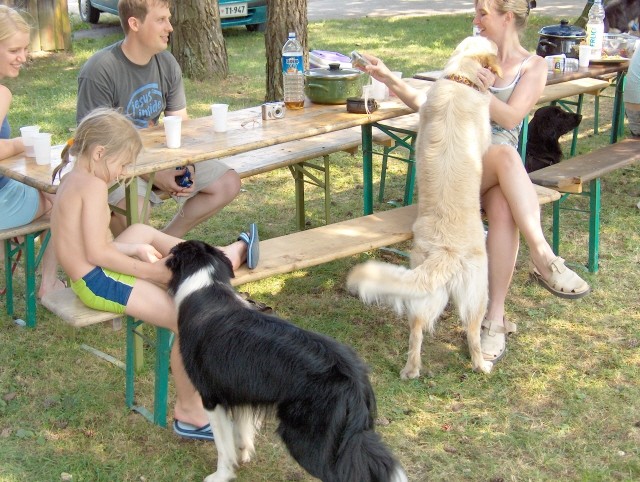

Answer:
[304,63,364,104]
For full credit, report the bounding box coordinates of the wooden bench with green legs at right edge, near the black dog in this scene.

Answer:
[529,138,640,273]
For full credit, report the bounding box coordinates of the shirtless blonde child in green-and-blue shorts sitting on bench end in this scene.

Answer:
[51,108,228,440]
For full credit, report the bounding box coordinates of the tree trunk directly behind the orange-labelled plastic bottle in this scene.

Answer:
[264,0,309,102]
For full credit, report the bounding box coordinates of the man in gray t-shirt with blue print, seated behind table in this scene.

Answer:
[76,1,245,245]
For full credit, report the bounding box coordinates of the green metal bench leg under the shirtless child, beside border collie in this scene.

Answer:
[125,316,173,427]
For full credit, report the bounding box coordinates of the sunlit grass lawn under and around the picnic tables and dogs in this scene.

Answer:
[0,11,640,482]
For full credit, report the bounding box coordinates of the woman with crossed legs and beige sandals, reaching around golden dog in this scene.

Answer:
[358,0,590,362]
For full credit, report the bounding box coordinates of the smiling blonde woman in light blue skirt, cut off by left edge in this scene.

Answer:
[0,5,64,297]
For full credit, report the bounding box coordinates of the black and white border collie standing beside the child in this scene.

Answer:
[166,241,407,482]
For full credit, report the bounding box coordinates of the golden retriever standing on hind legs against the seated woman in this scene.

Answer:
[347,36,501,379]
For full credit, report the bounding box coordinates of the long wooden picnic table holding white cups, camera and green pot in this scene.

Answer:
[0,79,431,223]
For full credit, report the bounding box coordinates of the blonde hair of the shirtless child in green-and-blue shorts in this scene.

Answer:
[53,108,142,180]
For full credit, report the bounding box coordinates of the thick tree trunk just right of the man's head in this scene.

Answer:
[171,0,229,80]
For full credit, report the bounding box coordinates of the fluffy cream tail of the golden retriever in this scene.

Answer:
[347,255,462,314]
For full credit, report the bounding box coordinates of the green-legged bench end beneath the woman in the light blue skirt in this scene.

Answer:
[0,216,49,328]
